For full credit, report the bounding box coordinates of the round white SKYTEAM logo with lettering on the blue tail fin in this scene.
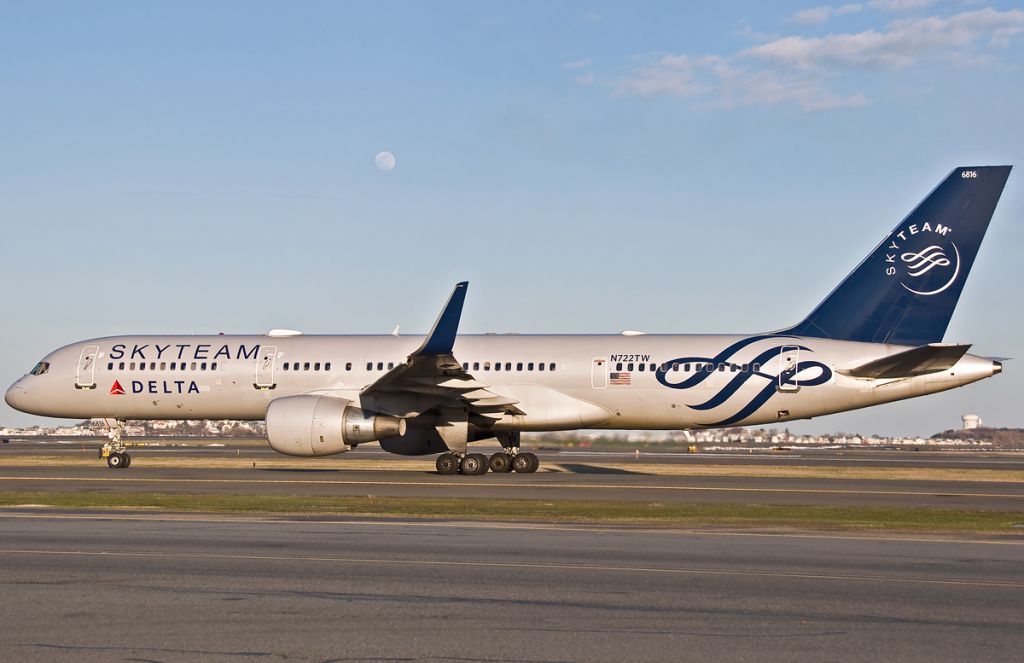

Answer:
[885,222,961,297]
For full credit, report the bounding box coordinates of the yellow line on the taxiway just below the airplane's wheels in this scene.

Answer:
[0,476,1024,499]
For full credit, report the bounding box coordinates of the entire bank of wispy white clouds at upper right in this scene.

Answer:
[589,0,1024,112]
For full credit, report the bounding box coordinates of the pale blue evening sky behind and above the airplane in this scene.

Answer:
[0,0,1024,434]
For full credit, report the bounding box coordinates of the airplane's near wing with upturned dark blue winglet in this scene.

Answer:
[359,281,523,422]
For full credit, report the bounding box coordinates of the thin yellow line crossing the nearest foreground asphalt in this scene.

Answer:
[0,548,1024,589]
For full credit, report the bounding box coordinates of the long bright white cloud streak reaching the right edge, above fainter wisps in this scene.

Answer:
[740,7,1024,70]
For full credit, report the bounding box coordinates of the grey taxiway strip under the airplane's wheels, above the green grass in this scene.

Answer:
[0,450,1024,511]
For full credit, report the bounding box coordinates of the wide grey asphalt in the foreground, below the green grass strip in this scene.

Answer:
[0,510,1024,663]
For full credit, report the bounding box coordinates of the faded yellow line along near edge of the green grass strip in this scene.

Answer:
[6,506,1024,546]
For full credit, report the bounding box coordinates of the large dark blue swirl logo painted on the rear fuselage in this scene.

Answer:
[655,334,833,426]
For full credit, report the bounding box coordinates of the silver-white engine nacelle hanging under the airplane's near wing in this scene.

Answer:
[266,396,406,456]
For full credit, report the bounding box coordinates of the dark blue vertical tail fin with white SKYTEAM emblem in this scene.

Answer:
[785,166,1011,345]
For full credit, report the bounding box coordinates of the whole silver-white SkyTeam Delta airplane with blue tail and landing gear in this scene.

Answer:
[5,166,1012,475]
